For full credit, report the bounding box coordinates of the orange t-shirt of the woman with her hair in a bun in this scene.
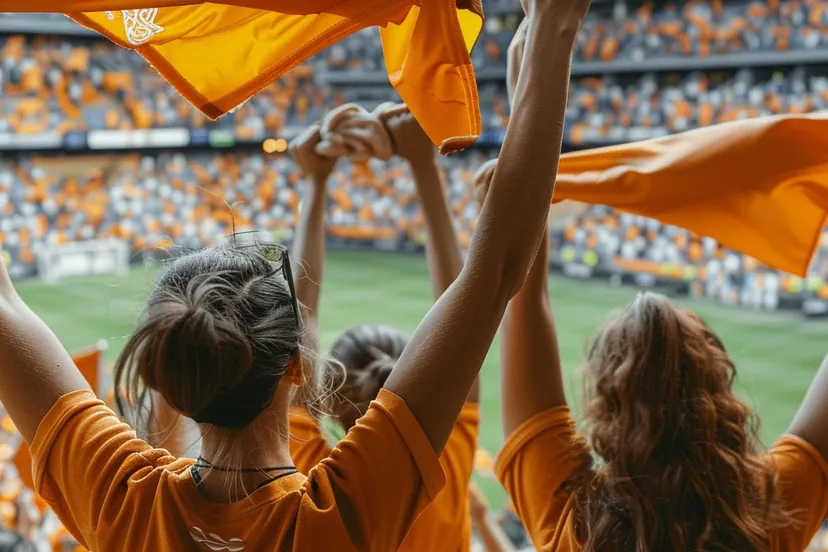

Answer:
[32,390,445,552]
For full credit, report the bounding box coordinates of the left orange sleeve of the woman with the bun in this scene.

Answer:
[32,390,169,549]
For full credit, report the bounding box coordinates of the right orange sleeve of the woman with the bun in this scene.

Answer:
[306,389,445,552]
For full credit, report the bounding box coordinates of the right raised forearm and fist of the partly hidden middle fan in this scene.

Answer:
[386,112,480,403]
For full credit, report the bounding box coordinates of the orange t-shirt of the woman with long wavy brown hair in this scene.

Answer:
[495,406,828,552]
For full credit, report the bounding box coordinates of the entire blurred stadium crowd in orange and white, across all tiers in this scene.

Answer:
[0,0,828,552]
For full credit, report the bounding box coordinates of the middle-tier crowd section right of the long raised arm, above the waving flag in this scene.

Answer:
[567,67,828,144]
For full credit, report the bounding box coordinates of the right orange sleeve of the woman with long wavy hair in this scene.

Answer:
[770,435,828,551]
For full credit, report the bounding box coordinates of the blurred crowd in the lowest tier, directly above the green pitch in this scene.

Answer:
[0,151,828,309]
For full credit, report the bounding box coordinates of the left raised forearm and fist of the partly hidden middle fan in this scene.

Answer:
[290,125,337,334]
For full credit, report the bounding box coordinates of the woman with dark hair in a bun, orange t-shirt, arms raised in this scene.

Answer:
[0,0,589,552]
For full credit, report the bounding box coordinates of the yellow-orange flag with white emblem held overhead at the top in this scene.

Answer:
[14,0,483,153]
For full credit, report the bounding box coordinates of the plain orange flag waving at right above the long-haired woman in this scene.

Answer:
[476,113,828,276]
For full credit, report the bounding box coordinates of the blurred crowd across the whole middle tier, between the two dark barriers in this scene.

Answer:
[0,28,828,144]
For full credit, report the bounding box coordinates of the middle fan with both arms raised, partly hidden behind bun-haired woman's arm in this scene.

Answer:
[290,106,480,552]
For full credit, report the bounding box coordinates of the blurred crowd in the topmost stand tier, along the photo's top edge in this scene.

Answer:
[308,0,828,71]
